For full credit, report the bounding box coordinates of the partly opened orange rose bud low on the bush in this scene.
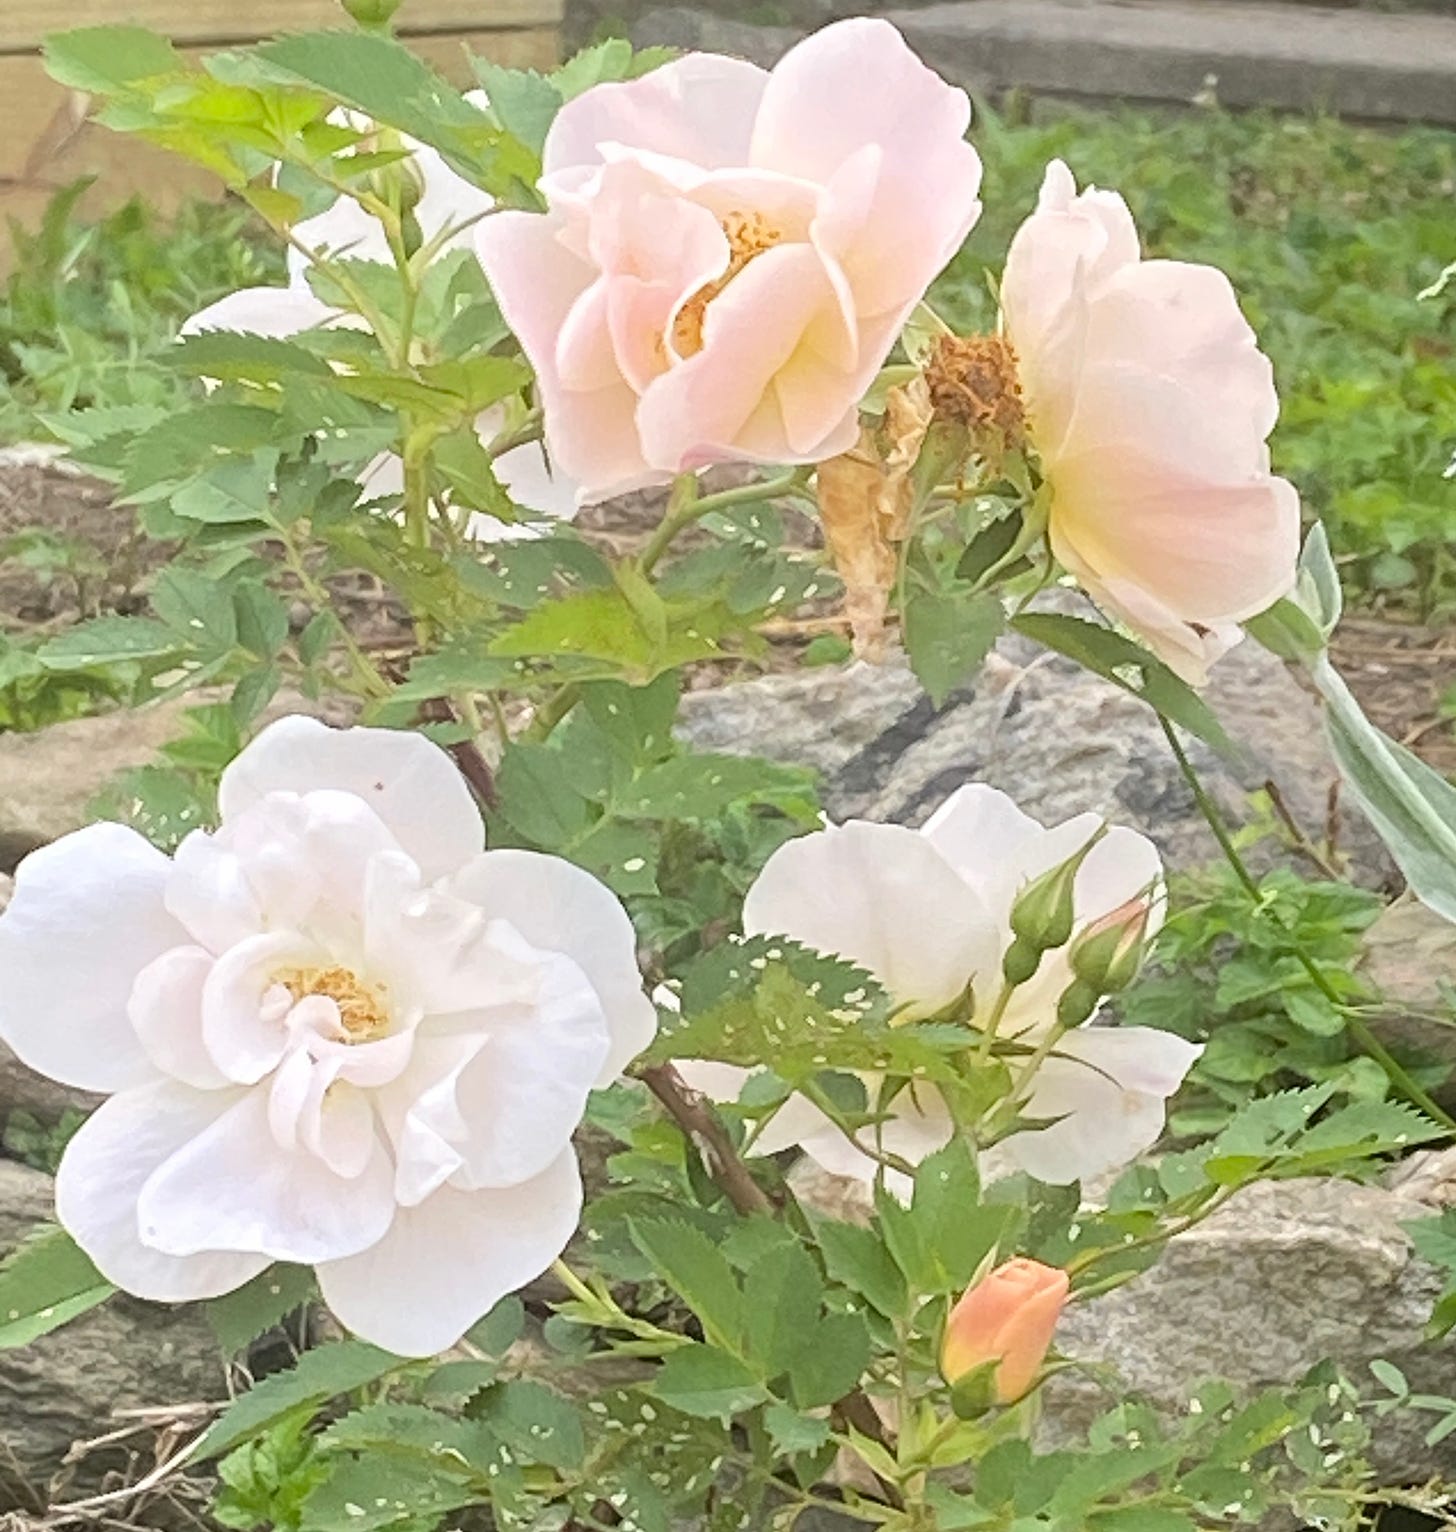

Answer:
[941,1258,1070,1405]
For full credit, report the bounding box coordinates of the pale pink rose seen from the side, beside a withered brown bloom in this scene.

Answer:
[1001,159,1300,685]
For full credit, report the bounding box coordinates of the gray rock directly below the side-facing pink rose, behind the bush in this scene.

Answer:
[682,625,1392,884]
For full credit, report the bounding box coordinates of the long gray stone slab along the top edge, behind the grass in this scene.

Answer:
[633,0,1456,124]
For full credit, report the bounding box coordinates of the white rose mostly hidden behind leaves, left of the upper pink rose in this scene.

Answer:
[179,121,576,542]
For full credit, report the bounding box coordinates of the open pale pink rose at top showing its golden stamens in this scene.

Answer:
[475,18,981,502]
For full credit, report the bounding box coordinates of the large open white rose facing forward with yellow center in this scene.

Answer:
[0,717,656,1356]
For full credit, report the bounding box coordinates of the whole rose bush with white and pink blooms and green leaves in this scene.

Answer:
[0,14,1456,1532]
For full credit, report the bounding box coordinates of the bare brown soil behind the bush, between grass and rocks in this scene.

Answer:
[0,453,1456,775]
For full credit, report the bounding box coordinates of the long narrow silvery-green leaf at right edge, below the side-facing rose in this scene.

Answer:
[1310,656,1456,921]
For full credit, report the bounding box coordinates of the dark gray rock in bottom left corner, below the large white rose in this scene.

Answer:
[0,1160,227,1511]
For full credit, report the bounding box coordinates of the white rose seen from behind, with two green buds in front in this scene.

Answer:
[679,783,1202,1190]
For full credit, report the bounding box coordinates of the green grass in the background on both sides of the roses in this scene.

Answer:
[0,100,1456,616]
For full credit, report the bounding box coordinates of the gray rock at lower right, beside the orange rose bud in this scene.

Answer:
[1045,1180,1456,1483]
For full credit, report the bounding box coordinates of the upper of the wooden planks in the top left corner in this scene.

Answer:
[0,0,564,54]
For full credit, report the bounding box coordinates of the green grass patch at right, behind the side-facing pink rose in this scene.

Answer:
[936,100,1456,616]
